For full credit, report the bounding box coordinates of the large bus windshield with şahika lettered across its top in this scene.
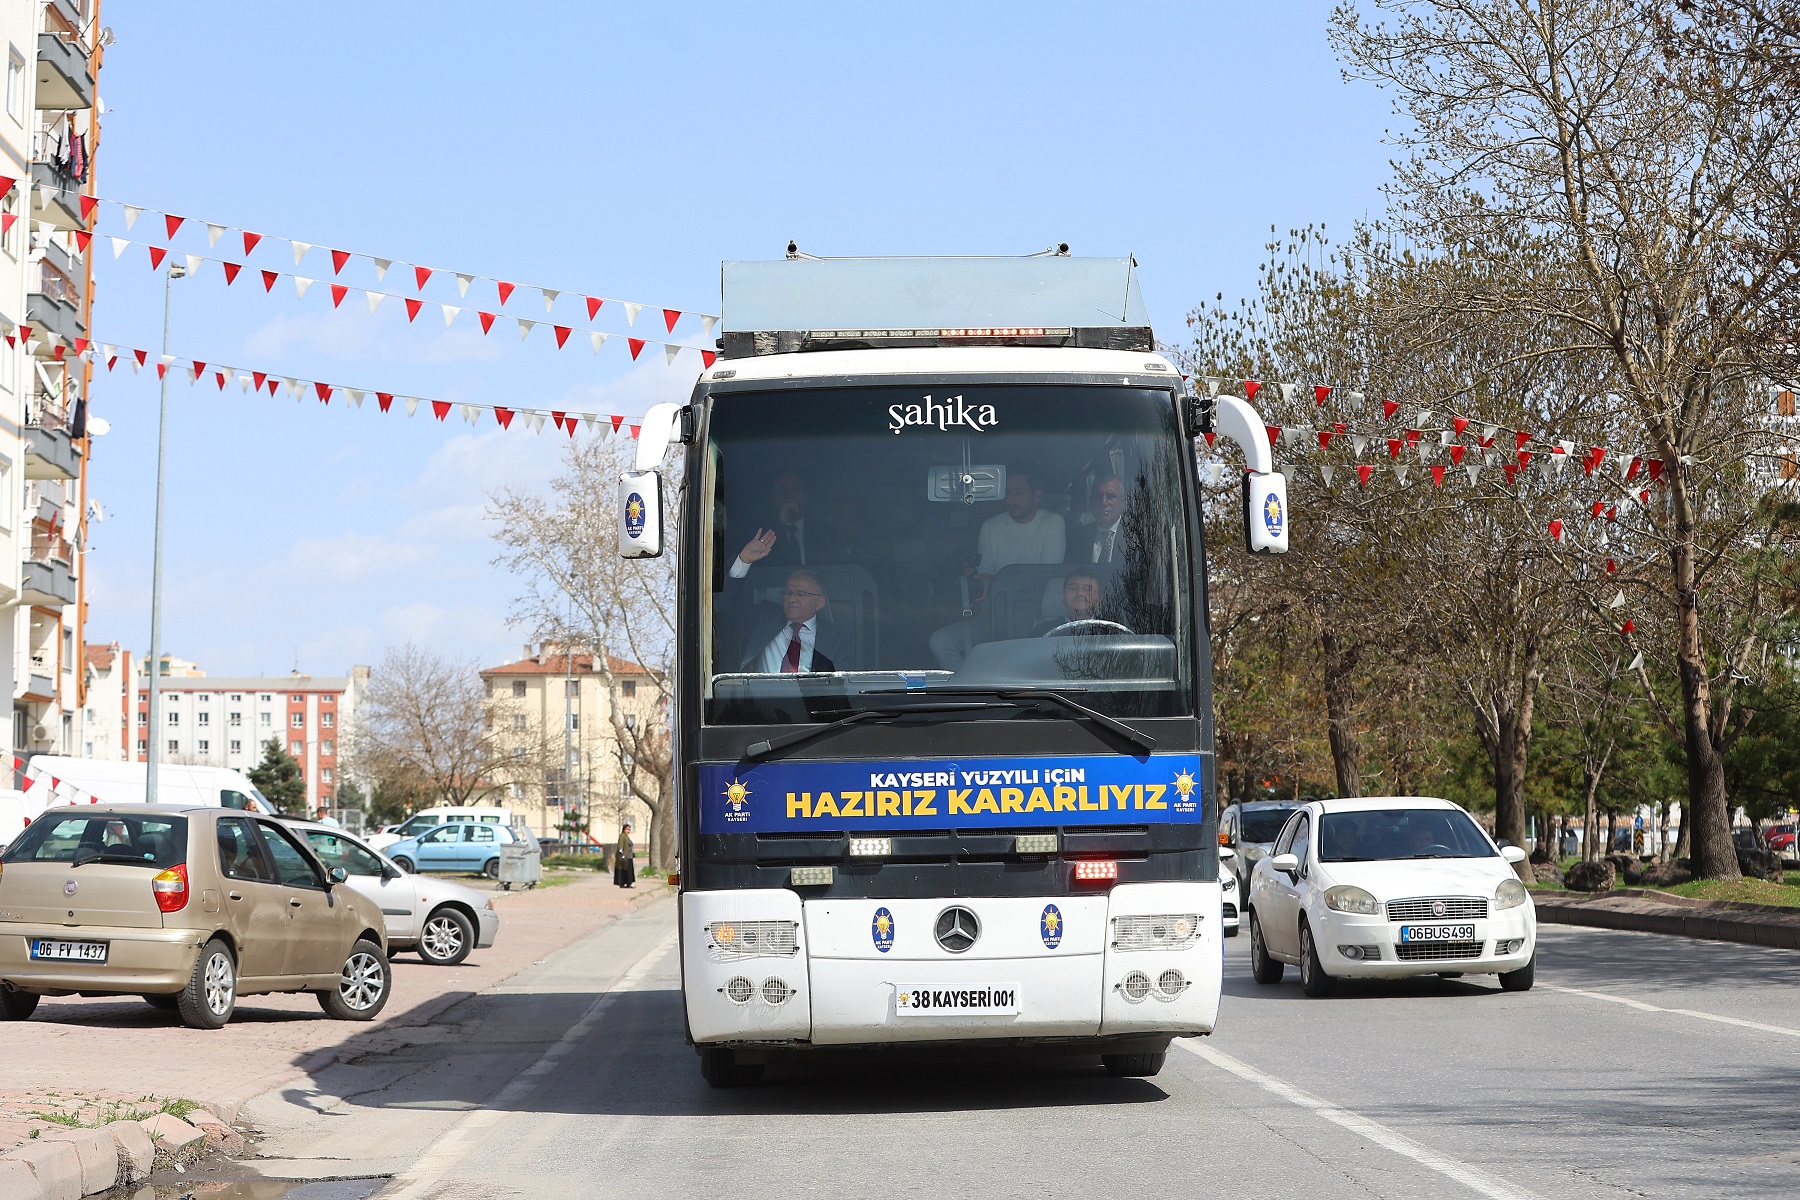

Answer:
[702,383,1195,725]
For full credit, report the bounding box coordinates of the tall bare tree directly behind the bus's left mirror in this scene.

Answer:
[488,439,680,871]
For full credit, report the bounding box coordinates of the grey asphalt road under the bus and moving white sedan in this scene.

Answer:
[247,903,1800,1200]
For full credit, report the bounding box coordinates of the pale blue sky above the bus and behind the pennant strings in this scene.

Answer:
[88,0,1388,675]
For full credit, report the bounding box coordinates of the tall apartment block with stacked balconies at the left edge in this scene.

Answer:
[0,0,112,784]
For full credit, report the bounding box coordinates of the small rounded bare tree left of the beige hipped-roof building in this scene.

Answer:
[346,642,508,806]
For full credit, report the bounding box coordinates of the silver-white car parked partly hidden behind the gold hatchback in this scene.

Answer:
[288,820,500,966]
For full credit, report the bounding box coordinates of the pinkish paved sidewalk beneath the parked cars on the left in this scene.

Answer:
[0,871,671,1151]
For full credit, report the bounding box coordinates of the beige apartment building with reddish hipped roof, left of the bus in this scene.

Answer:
[481,644,664,844]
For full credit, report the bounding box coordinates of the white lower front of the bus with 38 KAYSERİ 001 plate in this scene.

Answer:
[682,883,1224,1045]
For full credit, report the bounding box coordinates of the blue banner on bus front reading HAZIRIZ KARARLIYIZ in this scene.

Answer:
[700,754,1204,833]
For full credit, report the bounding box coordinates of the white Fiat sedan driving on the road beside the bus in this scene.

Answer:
[1246,797,1537,997]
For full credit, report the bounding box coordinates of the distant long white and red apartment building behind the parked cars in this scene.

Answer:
[131,655,369,811]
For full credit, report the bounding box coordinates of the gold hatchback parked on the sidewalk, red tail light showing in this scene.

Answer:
[0,804,392,1029]
